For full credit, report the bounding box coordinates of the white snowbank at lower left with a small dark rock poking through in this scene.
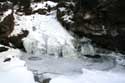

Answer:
[0,49,35,83]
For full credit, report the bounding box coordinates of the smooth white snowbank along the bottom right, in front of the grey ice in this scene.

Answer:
[50,69,125,83]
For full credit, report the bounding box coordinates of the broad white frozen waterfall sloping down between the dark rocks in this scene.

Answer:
[11,11,74,56]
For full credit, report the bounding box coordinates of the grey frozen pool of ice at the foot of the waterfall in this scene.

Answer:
[22,55,124,75]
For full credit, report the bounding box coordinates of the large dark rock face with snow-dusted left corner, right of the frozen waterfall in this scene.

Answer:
[57,0,125,53]
